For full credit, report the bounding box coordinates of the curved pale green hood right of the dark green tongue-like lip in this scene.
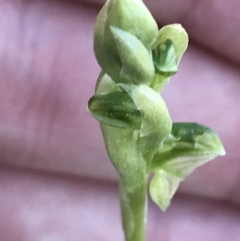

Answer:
[118,84,172,164]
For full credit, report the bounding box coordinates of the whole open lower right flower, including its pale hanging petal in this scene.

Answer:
[150,123,225,210]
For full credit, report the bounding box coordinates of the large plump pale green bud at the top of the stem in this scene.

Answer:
[94,0,158,83]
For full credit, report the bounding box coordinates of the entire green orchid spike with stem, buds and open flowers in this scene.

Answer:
[88,0,225,241]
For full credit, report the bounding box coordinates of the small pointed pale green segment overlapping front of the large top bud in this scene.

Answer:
[110,26,155,84]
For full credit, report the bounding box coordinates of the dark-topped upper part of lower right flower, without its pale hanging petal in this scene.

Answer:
[152,123,225,177]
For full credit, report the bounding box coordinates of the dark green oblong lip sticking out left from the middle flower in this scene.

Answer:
[88,91,142,130]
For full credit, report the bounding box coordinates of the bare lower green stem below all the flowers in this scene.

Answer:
[120,178,147,241]
